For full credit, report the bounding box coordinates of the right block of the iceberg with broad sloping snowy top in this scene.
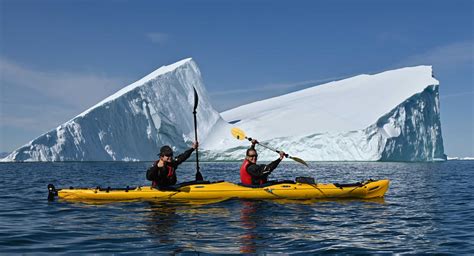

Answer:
[208,66,446,161]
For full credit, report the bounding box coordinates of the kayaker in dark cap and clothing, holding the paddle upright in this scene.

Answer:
[146,142,199,188]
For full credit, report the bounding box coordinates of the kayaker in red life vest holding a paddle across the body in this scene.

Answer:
[240,140,285,185]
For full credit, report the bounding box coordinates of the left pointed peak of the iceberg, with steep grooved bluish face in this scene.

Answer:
[2,59,224,161]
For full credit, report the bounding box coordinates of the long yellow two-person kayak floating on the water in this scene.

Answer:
[48,180,389,201]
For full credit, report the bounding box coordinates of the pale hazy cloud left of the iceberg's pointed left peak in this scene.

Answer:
[0,58,127,138]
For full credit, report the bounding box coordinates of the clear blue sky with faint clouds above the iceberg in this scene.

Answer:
[0,0,474,157]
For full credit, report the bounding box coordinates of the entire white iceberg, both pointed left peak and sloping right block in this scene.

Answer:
[3,59,446,161]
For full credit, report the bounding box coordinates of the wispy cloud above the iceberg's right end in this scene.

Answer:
[399,41,474,68]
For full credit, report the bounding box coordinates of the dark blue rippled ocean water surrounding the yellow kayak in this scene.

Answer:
[0,161,474,254]
